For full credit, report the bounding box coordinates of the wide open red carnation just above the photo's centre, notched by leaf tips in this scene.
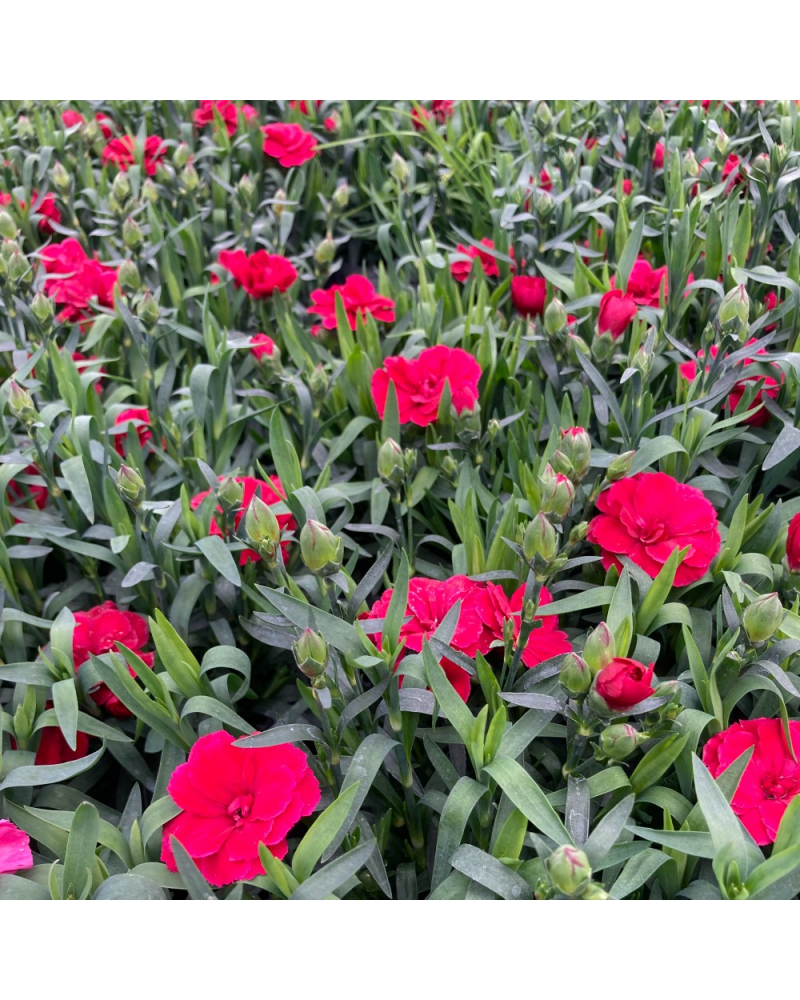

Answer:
[372,344,481,427]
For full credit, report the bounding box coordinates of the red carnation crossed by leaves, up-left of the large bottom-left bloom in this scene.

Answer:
[72,601,154,719]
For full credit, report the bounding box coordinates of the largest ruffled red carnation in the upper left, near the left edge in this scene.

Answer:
[40,239,117,324]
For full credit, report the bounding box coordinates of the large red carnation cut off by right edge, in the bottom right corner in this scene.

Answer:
[703,719,800,844]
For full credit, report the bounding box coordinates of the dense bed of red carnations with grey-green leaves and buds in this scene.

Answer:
[0,100,800,900]
